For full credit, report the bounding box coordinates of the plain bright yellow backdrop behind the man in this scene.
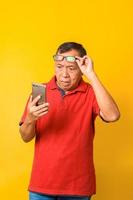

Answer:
[0,0,133,200]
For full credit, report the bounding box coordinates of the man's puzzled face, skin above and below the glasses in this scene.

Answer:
[55,49,82,91]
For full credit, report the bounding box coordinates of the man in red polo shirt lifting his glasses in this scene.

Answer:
[20,42,120,200]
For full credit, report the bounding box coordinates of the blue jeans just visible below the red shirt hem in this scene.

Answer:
[29,192,91,200]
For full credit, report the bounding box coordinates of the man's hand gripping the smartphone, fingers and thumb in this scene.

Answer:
[27,95,49,122]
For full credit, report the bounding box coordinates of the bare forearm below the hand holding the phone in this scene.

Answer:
[19,118,36,142]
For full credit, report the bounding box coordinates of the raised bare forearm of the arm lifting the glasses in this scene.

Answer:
[87,71,120,121]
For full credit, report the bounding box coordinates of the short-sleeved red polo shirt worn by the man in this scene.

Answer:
[21,77,100,196]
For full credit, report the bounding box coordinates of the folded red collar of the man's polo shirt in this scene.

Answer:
[48,76,88,94]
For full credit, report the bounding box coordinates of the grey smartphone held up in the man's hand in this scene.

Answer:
[32,83,46,106]
